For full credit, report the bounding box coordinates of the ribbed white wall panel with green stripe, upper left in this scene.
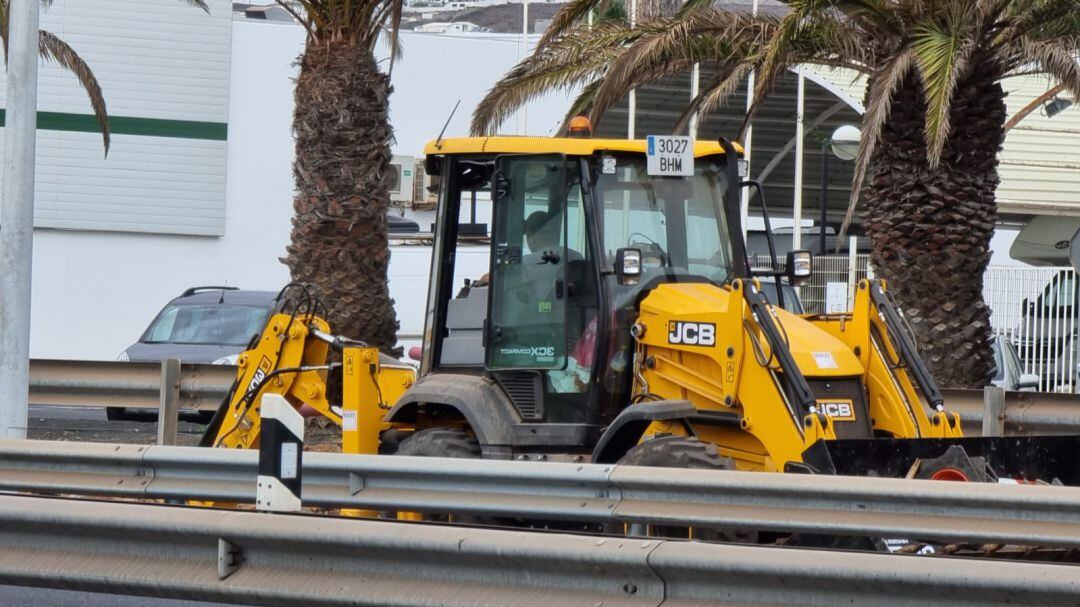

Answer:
[0,0,232,235]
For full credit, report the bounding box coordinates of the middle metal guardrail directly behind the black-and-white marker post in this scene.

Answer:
[6,441,1080,548]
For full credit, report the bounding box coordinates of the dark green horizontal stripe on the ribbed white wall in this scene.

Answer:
[0,109,229,141]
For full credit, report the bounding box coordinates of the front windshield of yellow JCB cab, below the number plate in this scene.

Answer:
[595,156,731,285]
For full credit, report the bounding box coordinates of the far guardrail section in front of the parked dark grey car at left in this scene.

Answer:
[30,359,237,410]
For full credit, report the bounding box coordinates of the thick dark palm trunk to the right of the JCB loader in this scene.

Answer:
[863,63,1005,388]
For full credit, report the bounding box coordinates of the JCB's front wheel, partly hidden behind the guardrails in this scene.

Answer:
[619,436,757,543]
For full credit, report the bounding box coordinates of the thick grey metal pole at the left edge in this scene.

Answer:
[0,0,38,439]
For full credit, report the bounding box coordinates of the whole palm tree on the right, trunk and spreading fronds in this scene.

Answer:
[474,0,1080,387]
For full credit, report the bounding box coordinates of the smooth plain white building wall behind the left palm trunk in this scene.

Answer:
[30,21,566,360]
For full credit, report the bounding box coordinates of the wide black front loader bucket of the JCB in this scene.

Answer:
[788,435,1080,486]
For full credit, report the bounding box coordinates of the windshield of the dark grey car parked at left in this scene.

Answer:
[141,304,268,346]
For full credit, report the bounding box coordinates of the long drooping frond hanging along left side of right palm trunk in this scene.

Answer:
[837,48,915,242]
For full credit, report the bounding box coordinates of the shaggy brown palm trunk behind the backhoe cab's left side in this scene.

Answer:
[284,43,397,352]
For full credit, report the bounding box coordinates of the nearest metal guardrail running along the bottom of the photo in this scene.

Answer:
[0,496,1080,607]
